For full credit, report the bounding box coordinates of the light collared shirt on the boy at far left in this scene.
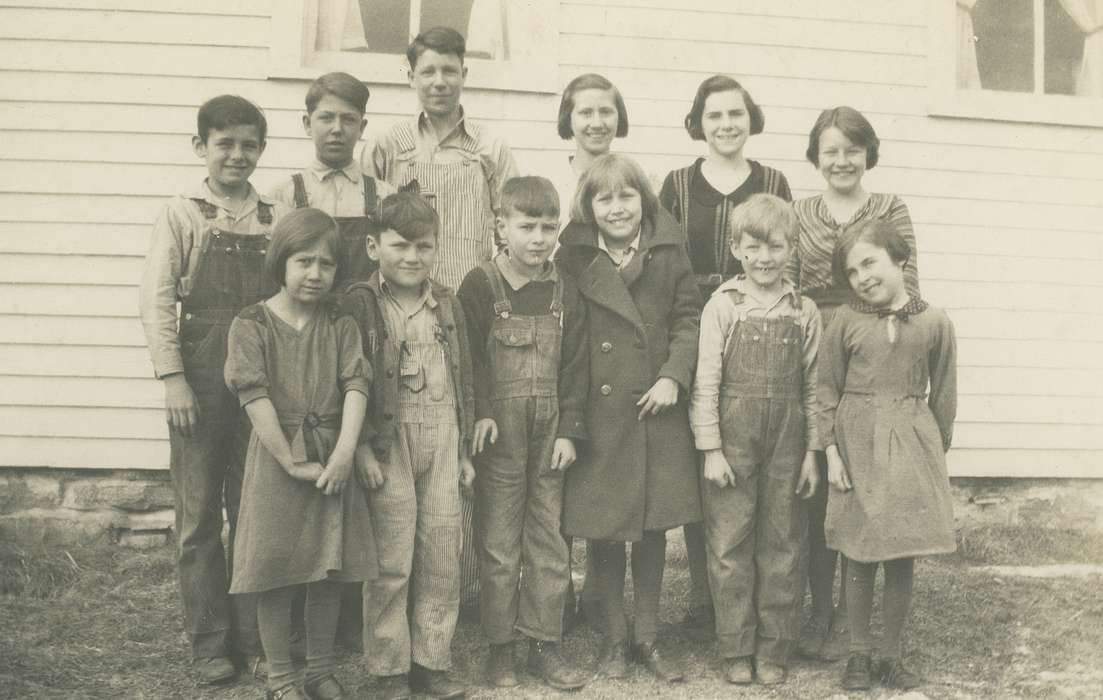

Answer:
[138,180,287,378]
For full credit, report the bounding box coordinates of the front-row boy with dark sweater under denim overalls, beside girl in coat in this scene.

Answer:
[458,176,589,690]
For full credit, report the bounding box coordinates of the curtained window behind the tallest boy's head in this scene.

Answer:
[269,0,560,93]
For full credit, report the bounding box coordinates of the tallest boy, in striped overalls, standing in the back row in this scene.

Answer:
[361,28,517,606]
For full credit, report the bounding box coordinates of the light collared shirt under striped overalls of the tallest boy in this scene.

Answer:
[360,108,521,212]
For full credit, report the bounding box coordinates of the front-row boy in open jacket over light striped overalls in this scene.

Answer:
[342,192,474,699]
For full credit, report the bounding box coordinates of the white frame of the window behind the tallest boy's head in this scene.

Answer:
[267,0,560,94]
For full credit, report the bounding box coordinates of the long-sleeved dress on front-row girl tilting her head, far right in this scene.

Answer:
[818,298,957,562]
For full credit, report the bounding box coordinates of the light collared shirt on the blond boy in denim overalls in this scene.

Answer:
[689,276,821,451]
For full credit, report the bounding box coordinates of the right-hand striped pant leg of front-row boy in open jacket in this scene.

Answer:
[410,424,461,670]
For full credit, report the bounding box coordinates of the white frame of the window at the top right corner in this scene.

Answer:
[927,0,1103,127]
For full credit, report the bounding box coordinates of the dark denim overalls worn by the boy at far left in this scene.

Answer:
[169,198,276,658]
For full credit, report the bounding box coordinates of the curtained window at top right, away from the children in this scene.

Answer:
[930,0,1103,126]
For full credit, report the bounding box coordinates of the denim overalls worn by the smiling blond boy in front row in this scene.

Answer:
[702,290,806,666]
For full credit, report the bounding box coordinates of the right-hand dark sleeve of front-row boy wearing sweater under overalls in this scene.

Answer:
[558,280,590,440]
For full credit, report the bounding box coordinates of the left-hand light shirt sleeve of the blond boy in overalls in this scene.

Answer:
[689,294,735,451]
